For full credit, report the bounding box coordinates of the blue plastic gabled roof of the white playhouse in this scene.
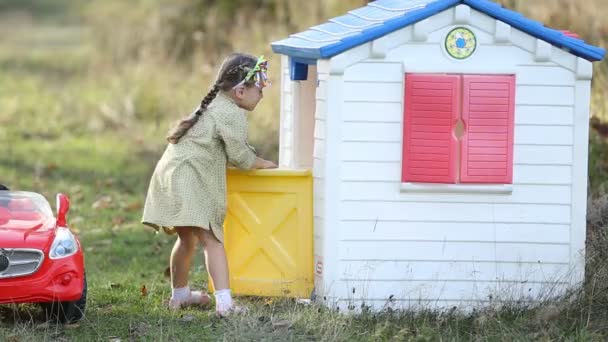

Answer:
[272,0,606,61]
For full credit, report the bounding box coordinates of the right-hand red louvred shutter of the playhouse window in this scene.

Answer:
[460,75,515,184]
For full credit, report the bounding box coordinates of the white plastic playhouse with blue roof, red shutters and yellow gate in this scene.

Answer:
[226,0,605,310]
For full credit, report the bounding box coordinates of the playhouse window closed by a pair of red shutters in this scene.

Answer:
[402,74,515,184]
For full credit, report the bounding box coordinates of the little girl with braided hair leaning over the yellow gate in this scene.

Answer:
[142,54,276,316]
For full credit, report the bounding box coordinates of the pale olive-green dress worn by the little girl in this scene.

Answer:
[142,93,256,242]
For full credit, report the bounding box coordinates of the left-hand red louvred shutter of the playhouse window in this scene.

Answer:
[401,74,461,183]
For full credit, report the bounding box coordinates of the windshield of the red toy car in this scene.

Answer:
[0,191,53,225]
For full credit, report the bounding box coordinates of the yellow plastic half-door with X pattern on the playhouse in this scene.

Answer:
[210,169,313,298]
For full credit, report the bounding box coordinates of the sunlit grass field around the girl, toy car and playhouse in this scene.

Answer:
[0,0,608,341]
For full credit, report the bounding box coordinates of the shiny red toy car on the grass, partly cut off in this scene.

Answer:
[0,190,87,322]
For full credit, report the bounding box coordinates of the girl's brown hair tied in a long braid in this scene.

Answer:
[167,53,257,144]
